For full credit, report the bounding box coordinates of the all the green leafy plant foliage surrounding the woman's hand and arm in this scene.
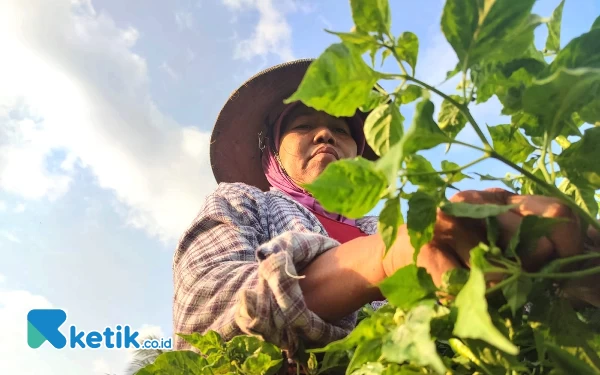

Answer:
[138,0,600,375]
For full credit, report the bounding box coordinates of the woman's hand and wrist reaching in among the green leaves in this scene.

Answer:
[383,189,597,285]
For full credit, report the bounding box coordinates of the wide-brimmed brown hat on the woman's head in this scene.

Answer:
[210,59,378,191]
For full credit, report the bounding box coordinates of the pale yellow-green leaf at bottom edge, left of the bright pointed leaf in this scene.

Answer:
[381,305,446,374]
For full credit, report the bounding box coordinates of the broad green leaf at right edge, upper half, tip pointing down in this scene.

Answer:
[523,67,600,138]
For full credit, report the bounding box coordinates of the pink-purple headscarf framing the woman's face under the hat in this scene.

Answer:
[262,102,365,226]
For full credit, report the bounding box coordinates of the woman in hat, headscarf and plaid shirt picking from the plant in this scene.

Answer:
[173,60,596,362]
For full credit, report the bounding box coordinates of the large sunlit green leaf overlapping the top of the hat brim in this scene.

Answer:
[284,43,379,117]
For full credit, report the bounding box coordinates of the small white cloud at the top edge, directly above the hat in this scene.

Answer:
[222,0,298,61]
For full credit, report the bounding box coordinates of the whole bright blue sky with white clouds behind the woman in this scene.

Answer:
[0,0,600,374]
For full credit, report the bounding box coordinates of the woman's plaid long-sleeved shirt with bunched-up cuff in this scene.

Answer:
[173,183,385,353]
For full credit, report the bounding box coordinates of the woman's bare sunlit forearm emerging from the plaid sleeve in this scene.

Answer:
[300,225,459,321]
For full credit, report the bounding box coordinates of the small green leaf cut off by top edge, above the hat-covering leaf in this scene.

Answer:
[350,0,392,34]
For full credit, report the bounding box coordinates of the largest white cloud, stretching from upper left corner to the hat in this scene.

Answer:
[0,0,215,240]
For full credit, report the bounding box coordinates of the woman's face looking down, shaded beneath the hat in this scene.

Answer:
[279,104,357,184]
